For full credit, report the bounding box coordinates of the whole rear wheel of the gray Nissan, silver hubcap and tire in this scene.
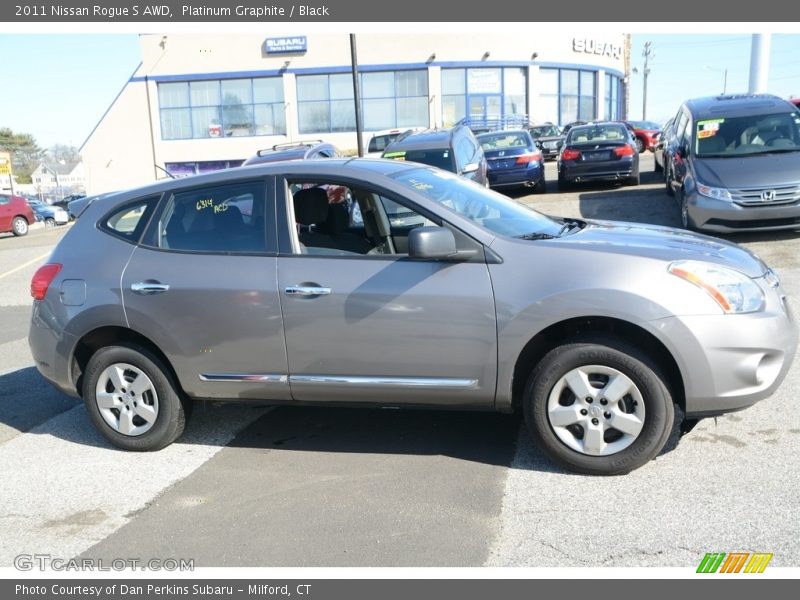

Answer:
[83,344,188,451]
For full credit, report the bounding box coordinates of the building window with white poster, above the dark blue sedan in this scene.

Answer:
[442,67,528,127]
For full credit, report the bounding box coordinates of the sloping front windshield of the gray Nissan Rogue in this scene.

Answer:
[391,169,562,237]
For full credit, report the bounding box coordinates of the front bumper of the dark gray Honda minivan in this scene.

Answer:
[686,191,800,233]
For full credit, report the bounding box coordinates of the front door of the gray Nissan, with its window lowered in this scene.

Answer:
[277,176,497,406]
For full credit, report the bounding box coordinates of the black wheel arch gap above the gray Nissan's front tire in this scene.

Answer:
[511,316,686,410]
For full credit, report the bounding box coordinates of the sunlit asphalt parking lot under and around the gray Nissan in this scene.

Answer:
[0,154,800,573]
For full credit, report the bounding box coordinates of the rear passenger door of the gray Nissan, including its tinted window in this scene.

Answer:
[122,179,290,400]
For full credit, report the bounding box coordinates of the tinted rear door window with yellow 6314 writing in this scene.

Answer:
[156,182,267,253]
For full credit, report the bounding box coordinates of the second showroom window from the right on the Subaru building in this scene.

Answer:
[539,69,597,125]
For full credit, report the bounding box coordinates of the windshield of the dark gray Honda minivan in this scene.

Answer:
[694,111,800,158]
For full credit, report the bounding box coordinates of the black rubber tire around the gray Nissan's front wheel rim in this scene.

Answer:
[523,336,675,475]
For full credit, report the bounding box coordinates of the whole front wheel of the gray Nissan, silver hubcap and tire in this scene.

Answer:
[524,336,675,475]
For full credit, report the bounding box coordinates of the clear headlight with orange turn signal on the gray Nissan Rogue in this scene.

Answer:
[668,260,764,313]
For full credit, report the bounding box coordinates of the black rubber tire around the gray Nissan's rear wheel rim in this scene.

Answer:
[83,343,191,452]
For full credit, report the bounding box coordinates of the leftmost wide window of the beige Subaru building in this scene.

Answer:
[158,77,286,140]
